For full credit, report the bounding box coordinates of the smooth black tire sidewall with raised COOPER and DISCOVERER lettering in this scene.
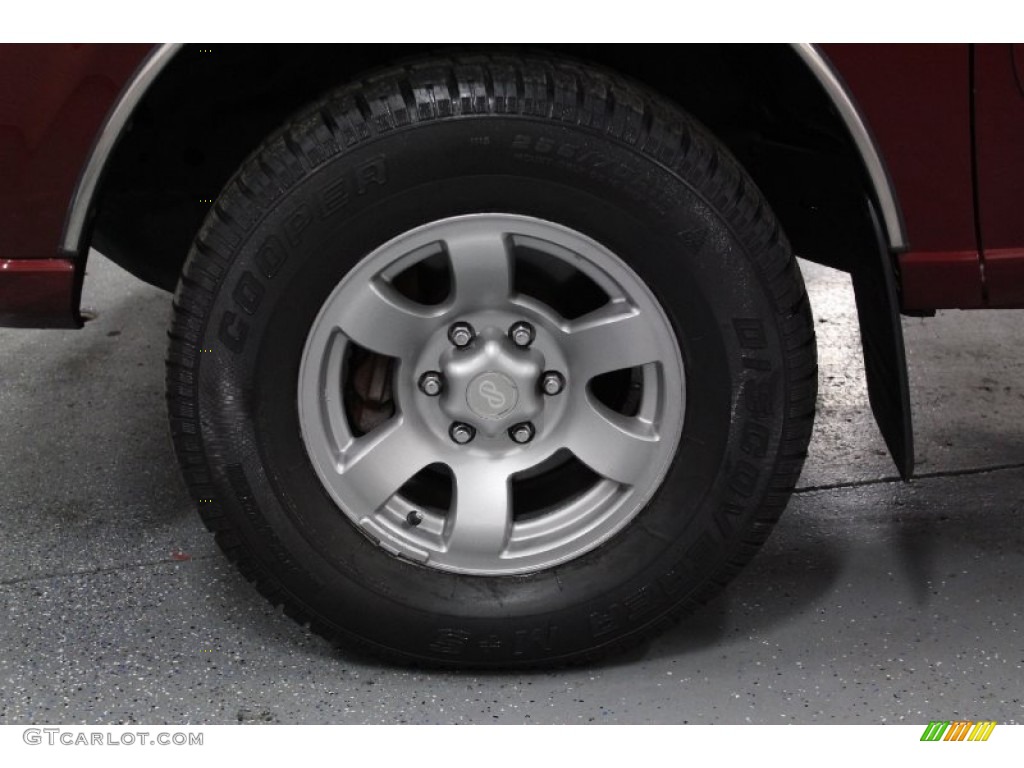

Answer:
[197,116,785,664]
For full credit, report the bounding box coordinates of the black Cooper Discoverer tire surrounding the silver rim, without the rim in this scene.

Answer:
[167,56,817,667]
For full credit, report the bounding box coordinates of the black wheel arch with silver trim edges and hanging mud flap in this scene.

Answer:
[77,44,913,475]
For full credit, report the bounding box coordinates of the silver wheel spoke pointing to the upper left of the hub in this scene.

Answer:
[335,280,436,357]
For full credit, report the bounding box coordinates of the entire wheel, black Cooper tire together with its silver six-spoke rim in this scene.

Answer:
[167,55,816,667]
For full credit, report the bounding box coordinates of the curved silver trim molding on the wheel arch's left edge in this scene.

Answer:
[60,43,182,254]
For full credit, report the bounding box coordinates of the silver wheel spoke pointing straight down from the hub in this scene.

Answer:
[447,462,512,561]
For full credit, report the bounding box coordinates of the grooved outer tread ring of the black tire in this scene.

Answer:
[166,55,817,667]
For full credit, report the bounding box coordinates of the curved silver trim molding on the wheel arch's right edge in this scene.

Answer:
[793,43,907,251]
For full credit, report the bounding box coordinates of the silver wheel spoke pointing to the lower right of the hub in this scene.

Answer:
[566,396,658,485]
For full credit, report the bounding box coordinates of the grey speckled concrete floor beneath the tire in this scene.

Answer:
[0,257,1024,723]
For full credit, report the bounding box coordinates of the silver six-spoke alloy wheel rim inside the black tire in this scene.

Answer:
[298,214,686,575]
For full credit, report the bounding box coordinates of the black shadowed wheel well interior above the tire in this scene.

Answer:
[91,45,878,290]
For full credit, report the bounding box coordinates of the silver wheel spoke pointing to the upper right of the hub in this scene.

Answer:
[564,301,664,382]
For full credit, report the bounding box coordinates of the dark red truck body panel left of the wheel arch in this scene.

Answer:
[0,45,152,326]
